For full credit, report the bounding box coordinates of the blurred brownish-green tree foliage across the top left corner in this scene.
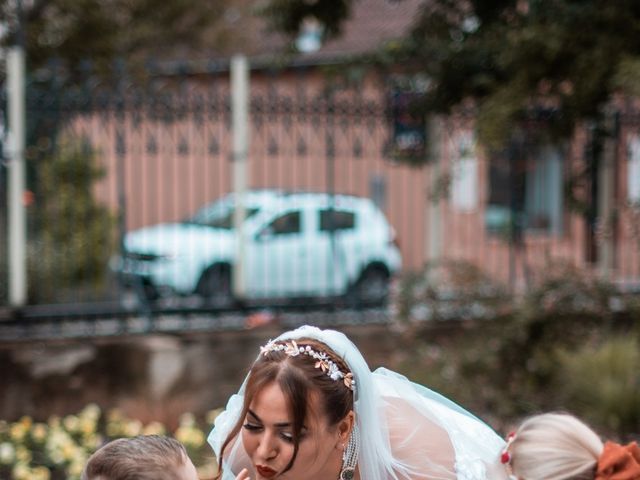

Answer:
[0,0,238,70]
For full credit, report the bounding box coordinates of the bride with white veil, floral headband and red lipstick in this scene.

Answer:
[209,326,506,480]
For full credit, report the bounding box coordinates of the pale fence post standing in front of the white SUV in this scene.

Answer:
[231,55,249,299]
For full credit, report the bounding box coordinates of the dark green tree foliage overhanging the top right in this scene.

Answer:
[264,0,640,148]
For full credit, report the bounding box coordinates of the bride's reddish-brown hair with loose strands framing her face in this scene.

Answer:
[216,338,353,479]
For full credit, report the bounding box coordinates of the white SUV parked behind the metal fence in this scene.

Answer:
[116,190,401,305]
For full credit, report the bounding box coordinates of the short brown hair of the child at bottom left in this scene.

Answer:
[82,435,187,480]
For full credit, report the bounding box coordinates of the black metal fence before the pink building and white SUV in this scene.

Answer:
[0,63,640,318]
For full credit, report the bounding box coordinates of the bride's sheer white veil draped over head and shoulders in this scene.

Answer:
[208,326,504,480]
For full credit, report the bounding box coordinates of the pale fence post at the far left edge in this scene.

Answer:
[7,45,27,307]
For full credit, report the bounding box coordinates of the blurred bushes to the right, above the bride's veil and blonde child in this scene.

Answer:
[396,264,640,438]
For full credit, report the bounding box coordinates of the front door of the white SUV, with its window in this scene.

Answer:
[247,208,310,298]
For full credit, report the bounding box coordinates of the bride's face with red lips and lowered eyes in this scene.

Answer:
[242,383,342,480]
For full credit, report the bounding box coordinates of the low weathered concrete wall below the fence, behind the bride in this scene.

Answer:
[0,326,399,426]
